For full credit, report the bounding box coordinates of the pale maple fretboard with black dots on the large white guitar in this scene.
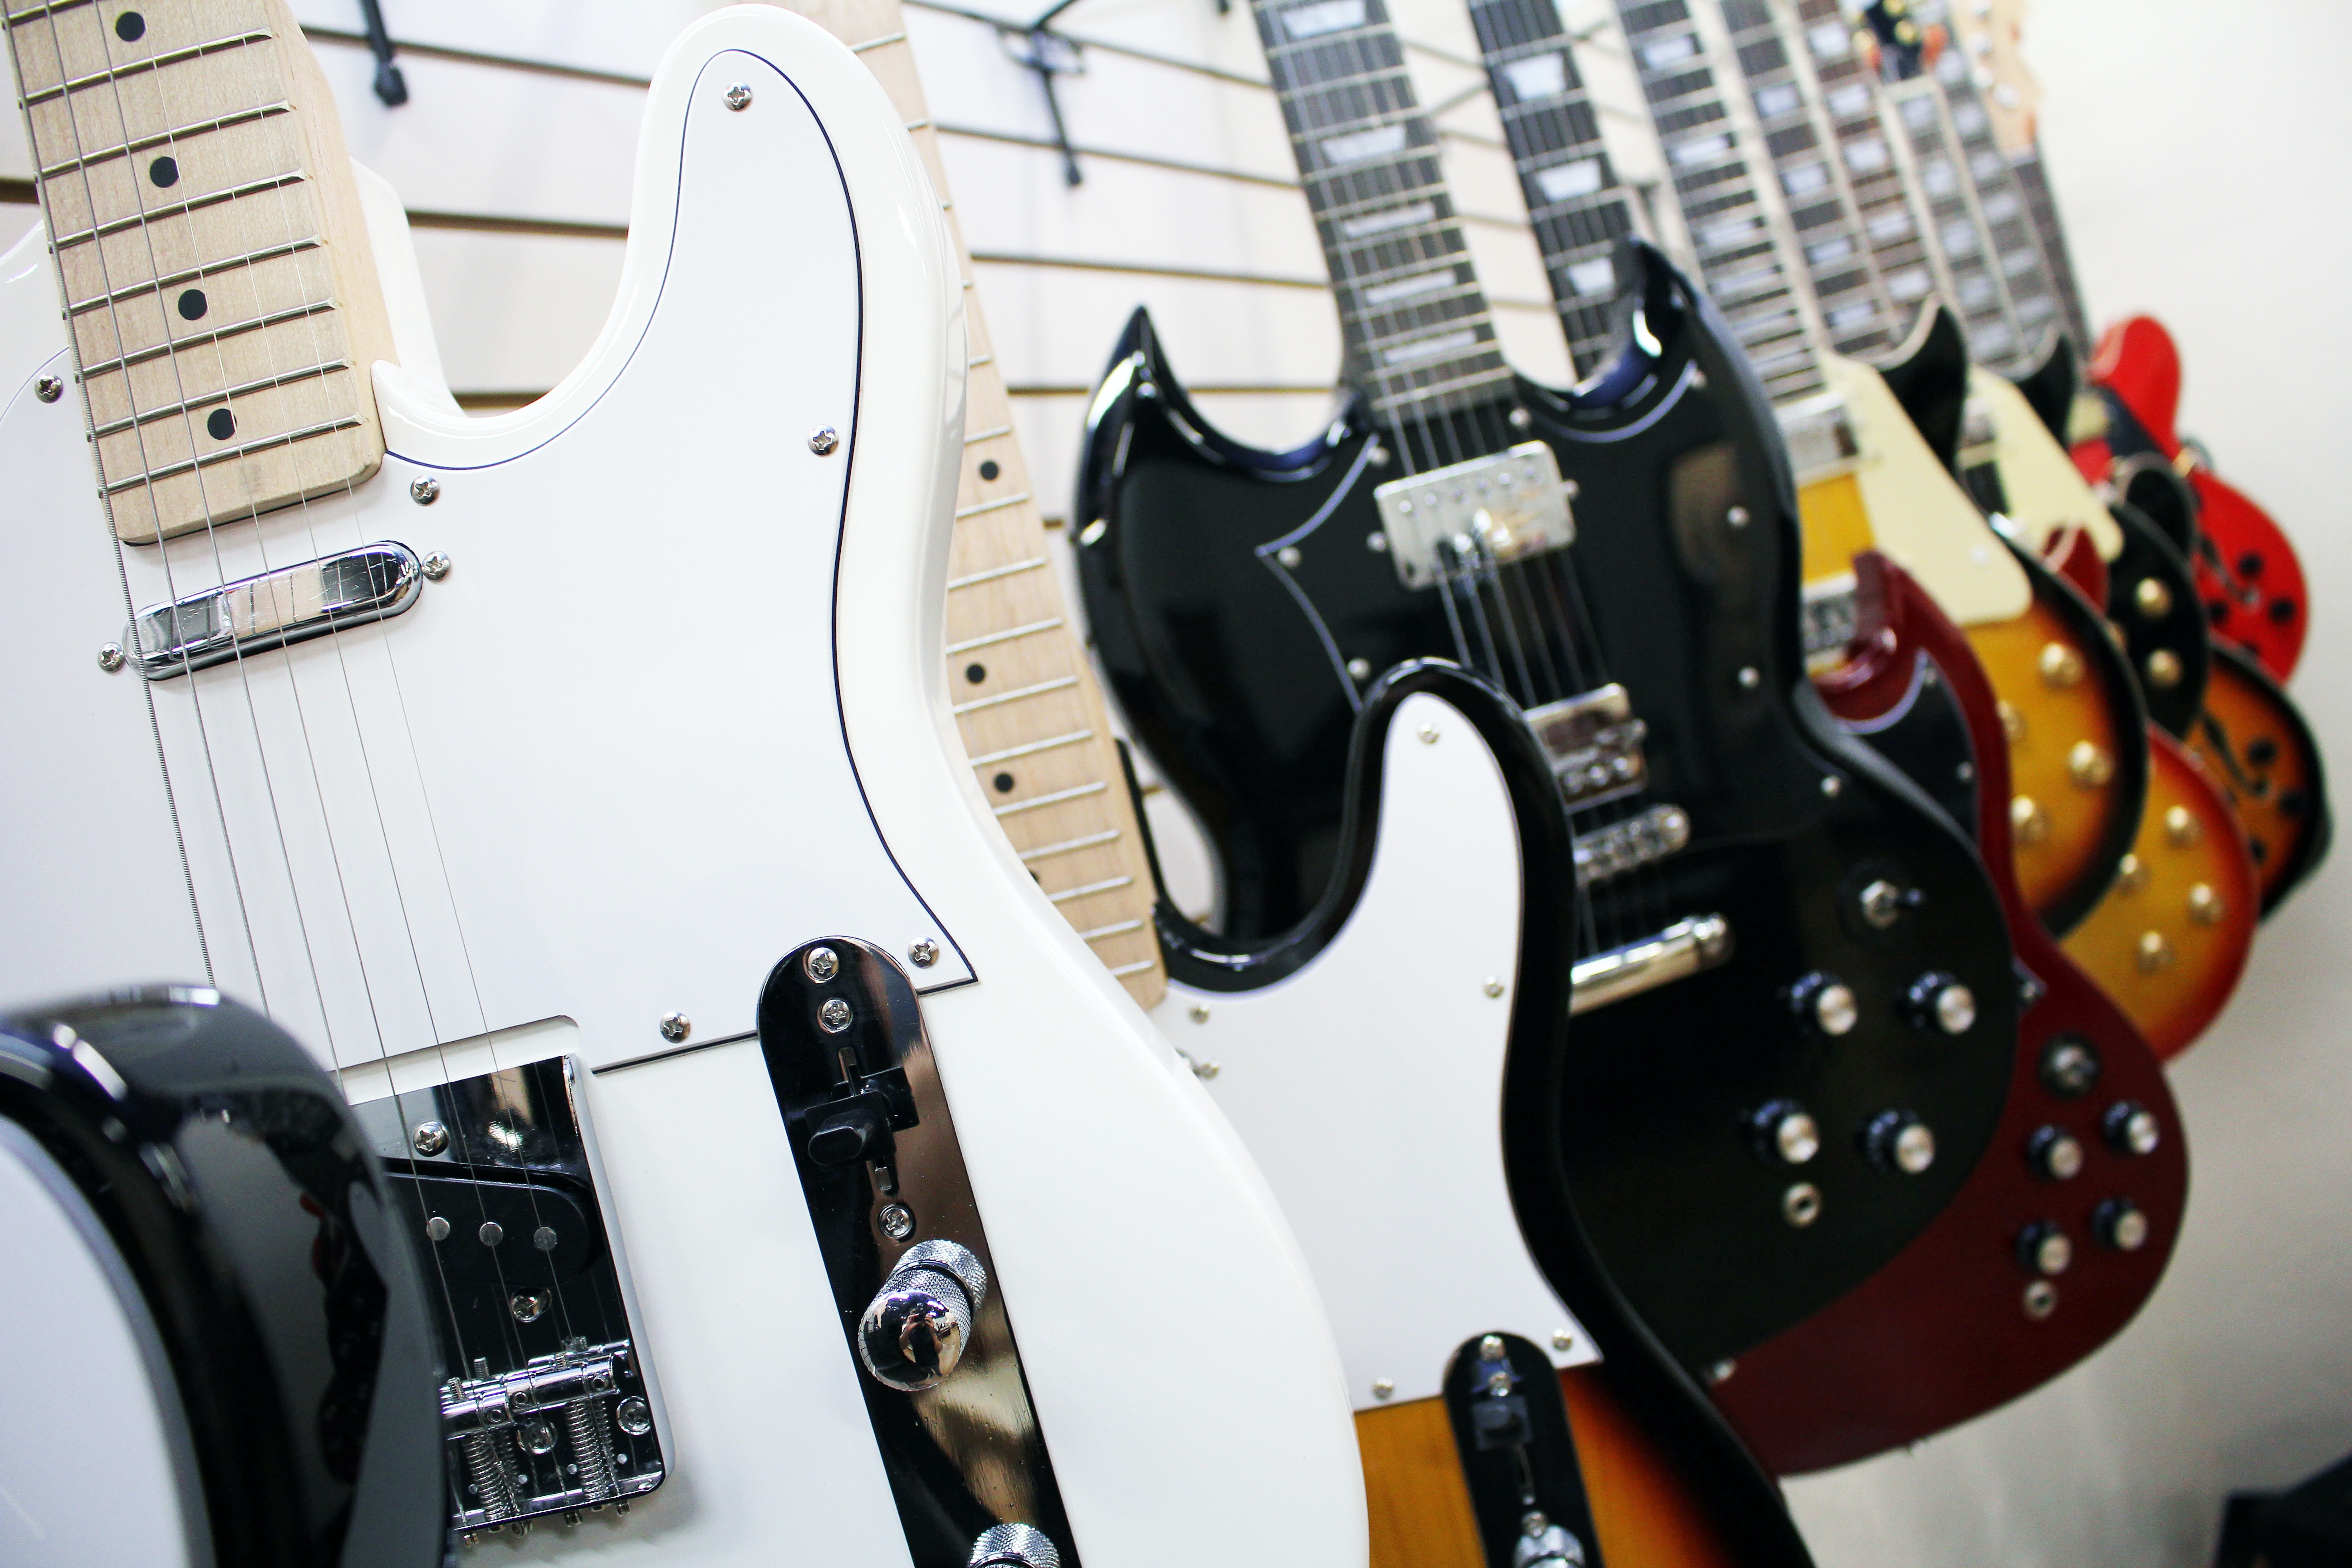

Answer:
[7,0,393,543]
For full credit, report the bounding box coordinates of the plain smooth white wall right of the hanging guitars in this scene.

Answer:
[1790,0,2352,1568]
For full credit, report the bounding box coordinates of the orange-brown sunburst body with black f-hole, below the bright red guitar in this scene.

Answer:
[2187,642,2333,917]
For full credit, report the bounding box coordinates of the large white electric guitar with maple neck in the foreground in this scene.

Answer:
[0,0,1364,1568]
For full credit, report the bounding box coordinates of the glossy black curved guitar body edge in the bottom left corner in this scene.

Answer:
[0,987,449,1568]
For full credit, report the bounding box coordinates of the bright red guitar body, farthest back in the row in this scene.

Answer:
[2074,315,2310,682]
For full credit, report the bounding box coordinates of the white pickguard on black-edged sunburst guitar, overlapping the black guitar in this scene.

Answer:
[1152,696,1595,1411]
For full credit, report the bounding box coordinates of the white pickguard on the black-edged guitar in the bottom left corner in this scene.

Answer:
[0,1119,197,1568]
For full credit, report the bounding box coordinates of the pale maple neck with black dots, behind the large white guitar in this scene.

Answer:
[790,0,1166,1009]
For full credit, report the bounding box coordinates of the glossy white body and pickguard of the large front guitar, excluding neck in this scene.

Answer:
[0,7,1364,1568]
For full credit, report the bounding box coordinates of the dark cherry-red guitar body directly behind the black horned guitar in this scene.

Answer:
[1712,555,2187,1476]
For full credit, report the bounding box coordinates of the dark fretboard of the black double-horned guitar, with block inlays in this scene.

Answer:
[1251,0,1510,423]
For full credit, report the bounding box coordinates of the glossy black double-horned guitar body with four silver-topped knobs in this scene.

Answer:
[1077,236,2016,1366]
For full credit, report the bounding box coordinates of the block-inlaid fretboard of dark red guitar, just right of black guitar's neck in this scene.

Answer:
[1470,0,1632,376]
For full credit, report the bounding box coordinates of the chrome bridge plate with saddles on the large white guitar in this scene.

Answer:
[353,1055,668,1540]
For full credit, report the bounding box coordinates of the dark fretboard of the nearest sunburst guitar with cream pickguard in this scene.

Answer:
[1618,0,1825,402]
